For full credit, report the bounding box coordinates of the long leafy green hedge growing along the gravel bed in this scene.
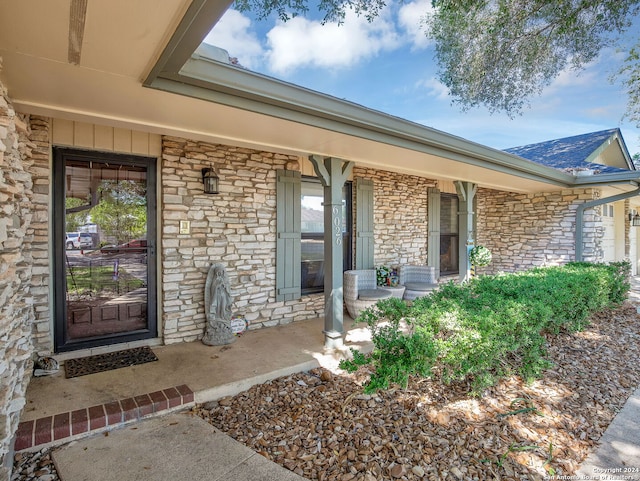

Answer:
[341,262,630,394]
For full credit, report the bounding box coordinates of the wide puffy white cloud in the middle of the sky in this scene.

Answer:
[267,11,400,75]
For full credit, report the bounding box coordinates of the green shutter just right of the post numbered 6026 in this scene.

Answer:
[355,178,374,269]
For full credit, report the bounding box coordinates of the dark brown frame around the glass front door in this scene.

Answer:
[52,147,158,352]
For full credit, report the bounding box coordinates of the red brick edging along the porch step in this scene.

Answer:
[14,384,194,451]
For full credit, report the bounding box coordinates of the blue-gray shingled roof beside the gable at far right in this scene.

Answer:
[505,128,628,173]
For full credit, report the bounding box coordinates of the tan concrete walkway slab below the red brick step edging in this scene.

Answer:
[53,413,304,481]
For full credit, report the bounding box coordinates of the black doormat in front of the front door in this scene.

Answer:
[64,346,158,378]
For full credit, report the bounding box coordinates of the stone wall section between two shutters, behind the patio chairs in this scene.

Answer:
[353,167,437,266]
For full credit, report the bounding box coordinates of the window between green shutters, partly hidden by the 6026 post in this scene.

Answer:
[300,177,352,294]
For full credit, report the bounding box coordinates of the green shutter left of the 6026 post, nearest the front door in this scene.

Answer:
[276,170,301,301]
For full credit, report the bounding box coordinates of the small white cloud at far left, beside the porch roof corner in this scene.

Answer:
[204,9,264,69]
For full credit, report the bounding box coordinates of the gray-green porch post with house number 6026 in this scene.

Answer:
[309,155,353,349]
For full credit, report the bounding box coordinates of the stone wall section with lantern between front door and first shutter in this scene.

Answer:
[160,137,324,344]
